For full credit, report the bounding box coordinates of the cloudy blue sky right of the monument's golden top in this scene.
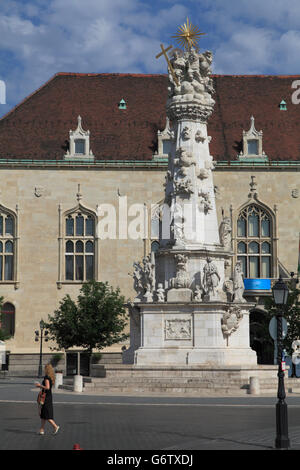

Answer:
[191,0,300,74]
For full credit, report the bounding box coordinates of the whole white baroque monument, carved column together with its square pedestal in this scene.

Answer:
[127,48,256,367]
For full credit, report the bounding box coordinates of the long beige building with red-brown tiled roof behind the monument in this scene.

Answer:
[0,74,300,353]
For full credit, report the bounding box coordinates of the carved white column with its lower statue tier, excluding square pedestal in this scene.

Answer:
[157,48,228,301]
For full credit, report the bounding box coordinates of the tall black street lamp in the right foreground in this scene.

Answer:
[272,276,290,449]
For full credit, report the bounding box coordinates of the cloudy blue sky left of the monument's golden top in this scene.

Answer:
[0,0,186,112]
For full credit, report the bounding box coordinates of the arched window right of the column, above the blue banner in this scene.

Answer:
[237,204,273,279]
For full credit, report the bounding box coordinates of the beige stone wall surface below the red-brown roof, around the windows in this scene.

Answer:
[0,167,300,353]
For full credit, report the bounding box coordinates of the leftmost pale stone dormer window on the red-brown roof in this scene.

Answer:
[64,116,94,160]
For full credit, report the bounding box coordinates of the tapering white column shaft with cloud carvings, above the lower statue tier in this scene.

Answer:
[161,49,220,249]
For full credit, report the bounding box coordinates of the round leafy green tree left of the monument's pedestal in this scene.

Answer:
[46,281,128,355]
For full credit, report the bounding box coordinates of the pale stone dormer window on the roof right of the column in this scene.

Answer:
[238,116,268,161]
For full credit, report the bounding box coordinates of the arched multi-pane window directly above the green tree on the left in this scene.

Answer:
[64,210,95,282]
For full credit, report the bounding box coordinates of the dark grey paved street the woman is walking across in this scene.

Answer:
[0,378,300,455]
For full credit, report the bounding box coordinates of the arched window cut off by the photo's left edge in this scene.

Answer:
[0,210,16,282]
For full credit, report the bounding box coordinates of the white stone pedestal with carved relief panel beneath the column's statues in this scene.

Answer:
[134,302,257,366]
